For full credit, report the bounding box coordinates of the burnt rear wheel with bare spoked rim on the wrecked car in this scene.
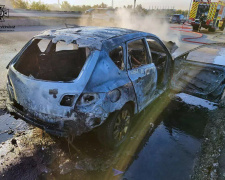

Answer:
[97,104,133,149]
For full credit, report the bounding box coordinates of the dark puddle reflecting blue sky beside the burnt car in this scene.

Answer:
[124,103,206,180]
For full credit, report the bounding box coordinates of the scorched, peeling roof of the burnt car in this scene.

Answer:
[35,27,154,50]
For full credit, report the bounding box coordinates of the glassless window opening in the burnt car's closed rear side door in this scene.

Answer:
[128,40,148,69]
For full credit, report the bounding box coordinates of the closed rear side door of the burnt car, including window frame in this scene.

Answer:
[126,38,157,111]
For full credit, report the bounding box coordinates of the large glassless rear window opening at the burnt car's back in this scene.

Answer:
[14,39,90,81]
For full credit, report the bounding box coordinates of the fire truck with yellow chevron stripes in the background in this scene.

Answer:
[189,0,225,32]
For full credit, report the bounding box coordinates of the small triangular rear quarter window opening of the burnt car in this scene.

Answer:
[109,46,124,70]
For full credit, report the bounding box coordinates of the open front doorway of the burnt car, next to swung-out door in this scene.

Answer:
[147,39,167,86]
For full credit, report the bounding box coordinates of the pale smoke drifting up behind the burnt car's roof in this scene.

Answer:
[79,8,180,44]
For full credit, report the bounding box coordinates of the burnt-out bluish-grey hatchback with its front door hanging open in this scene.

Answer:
[4,27,225,148]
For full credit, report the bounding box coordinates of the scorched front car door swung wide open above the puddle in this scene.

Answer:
[171,44,225,102]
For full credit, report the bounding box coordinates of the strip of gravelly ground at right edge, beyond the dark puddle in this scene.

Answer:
[192,108,225,180]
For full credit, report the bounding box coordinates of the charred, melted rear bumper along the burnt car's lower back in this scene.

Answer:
[6,99,106,137]
